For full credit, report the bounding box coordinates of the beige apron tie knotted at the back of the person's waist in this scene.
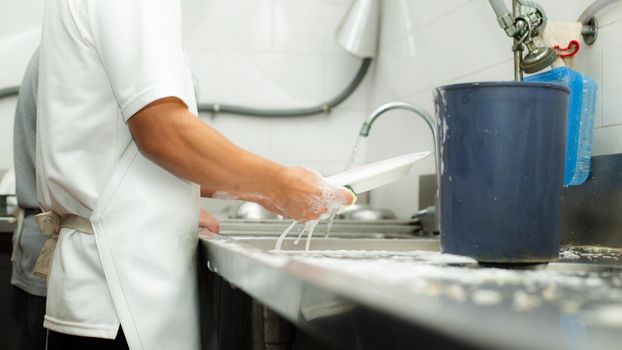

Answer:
[33,211,94,278]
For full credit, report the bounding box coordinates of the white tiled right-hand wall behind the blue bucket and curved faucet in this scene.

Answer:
[367,0,622,216]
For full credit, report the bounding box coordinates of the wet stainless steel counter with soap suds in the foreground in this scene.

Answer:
[202,232,622,349]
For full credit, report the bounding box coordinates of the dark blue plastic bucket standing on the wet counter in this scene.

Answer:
[434,82,568,263]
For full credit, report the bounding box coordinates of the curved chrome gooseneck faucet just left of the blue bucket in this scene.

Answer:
[359,102,441,230]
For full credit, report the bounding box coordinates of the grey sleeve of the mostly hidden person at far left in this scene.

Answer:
[13,49,39,209]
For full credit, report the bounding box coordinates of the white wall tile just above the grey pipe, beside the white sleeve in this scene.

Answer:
[187,49,324,108]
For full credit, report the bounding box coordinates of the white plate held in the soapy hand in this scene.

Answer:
[326,151,430,194]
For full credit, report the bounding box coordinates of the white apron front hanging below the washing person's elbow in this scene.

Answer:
[91,141,200,350]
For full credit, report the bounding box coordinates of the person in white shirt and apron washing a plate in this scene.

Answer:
[35,0,352,349]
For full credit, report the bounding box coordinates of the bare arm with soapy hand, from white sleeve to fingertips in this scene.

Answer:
[128,98,352,221]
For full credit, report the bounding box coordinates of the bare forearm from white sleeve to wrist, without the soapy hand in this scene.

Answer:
[128,98,284,197]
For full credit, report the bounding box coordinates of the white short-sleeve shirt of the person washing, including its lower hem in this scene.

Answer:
[37,0,196,338]
